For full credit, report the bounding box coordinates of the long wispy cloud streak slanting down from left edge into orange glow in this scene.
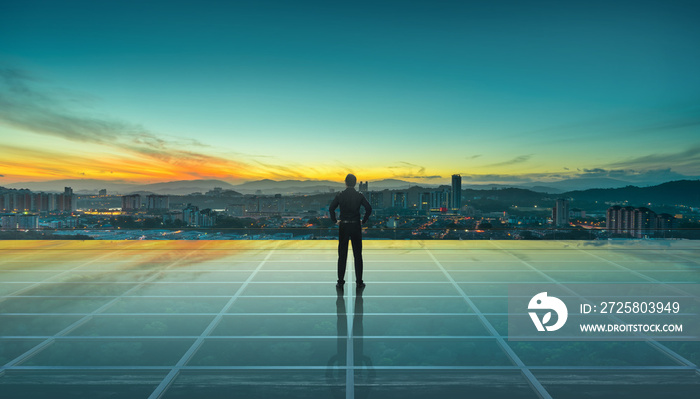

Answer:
[0,66,278,183]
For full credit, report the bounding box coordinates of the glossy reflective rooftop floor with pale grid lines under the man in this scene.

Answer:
[0,241,700,399]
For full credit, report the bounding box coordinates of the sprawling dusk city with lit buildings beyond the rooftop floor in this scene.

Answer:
[0,175,699,240]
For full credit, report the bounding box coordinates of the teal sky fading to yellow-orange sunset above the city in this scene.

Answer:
[0,0,700,186]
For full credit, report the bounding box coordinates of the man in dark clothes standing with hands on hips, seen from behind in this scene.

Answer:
[329,174,372,289]
